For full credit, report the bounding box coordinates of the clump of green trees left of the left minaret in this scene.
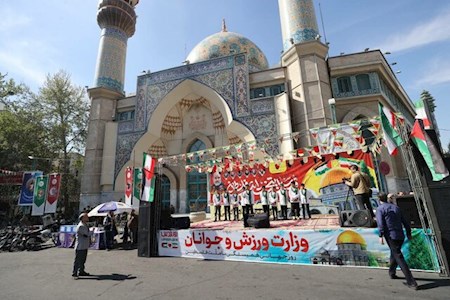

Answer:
[0,71,89,218]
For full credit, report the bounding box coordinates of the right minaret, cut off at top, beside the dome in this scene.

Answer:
[278,0,331,146]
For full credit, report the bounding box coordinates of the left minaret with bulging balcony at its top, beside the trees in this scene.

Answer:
[80,0,139,208]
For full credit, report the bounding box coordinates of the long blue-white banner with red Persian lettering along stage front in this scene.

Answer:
[158,228,438,271]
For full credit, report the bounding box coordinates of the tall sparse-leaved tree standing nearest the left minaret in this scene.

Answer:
[33,71,89,215]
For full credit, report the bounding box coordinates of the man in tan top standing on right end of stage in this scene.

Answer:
[344,165,375,218]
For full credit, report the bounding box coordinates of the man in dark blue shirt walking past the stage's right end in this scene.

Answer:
[377,193,418,290]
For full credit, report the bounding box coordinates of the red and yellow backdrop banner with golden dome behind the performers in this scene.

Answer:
[208,150,377,209]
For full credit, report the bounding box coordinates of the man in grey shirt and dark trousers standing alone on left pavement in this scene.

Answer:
[72,213,91,279]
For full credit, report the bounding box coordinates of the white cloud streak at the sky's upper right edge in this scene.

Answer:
[379,11,450,52]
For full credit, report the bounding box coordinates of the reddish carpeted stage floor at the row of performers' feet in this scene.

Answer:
[191,215,340,231]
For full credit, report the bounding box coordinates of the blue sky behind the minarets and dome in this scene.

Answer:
[0,0,450,149]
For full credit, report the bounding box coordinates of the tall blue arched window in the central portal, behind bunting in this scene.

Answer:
[187,140,207,212]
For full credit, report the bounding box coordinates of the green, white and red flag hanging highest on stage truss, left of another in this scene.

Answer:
[378,103,403,155]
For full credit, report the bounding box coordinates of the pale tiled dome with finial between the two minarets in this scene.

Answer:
[187,26,269,70]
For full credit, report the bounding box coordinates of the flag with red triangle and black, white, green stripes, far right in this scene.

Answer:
[411,120,448,181]
